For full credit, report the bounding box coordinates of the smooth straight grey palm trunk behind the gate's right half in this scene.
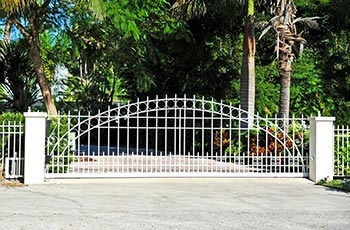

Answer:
[240,12,255,128]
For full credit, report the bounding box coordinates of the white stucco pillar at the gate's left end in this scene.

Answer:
[24,112,47,184]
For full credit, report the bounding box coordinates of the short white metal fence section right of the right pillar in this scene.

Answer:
[334,126,350,177]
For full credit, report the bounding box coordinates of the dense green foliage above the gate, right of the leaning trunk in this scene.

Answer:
[0,0,350,124]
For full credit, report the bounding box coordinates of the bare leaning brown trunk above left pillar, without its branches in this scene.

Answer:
[28,19,57,115]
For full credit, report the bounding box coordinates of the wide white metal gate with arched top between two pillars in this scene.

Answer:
[46,96,308,178]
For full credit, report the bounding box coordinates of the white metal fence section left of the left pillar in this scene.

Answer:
[0,122,24,179]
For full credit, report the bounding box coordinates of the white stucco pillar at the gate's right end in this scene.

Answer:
[309,116,335,183]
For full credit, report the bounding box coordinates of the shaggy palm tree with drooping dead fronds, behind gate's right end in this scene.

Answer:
[259,0,318,122]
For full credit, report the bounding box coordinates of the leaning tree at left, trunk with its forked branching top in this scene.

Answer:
[0,0,57,115]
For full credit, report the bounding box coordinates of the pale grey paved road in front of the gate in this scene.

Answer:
[0,179,350,230]
